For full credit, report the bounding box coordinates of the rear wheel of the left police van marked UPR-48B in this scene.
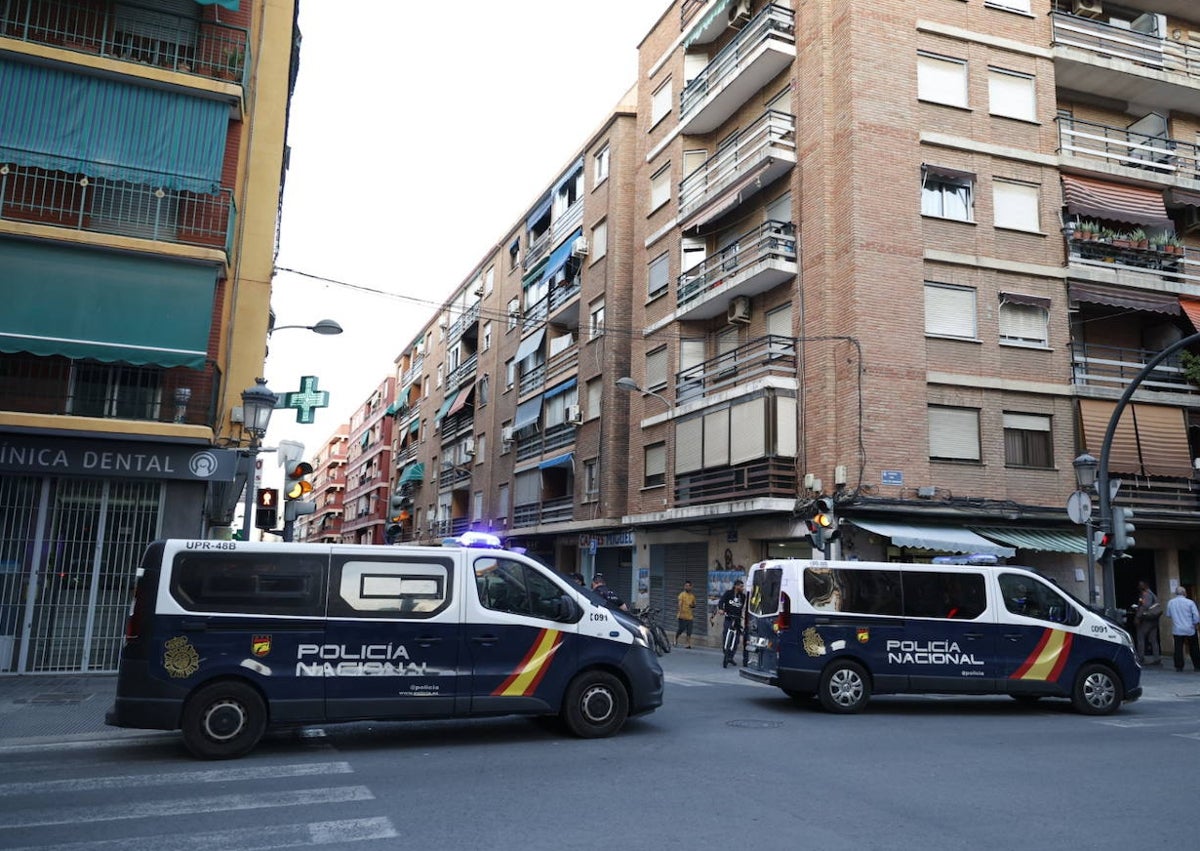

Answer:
[180,679,266,760]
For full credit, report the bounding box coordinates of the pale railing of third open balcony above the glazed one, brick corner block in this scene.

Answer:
[679,109,796,220]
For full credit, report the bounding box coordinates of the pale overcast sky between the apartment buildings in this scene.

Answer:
[266,0,668,456]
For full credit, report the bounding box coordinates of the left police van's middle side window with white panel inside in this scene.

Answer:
[329,559,454,619]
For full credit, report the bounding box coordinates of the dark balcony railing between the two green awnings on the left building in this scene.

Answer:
[0,149,236,254]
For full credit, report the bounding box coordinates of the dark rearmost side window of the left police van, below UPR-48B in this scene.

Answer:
[170,552,325,617]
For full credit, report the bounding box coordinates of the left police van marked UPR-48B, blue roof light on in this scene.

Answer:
[106,537,662,759]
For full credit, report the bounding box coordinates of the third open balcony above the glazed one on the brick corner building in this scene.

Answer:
[679,109,796,230]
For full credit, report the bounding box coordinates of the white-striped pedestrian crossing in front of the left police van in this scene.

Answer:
[0,748,398,851]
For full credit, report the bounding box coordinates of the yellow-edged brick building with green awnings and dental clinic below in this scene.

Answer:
[0,0,299,672]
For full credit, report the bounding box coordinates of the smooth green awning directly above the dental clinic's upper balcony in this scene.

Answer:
[0,239,217,368]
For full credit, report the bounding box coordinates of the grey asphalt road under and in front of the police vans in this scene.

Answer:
[0,649,1200,851]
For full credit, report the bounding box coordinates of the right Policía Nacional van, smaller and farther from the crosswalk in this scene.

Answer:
[740,559,1141,715]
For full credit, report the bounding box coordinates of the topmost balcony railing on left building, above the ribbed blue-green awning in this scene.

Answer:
[0,0,250,85]
